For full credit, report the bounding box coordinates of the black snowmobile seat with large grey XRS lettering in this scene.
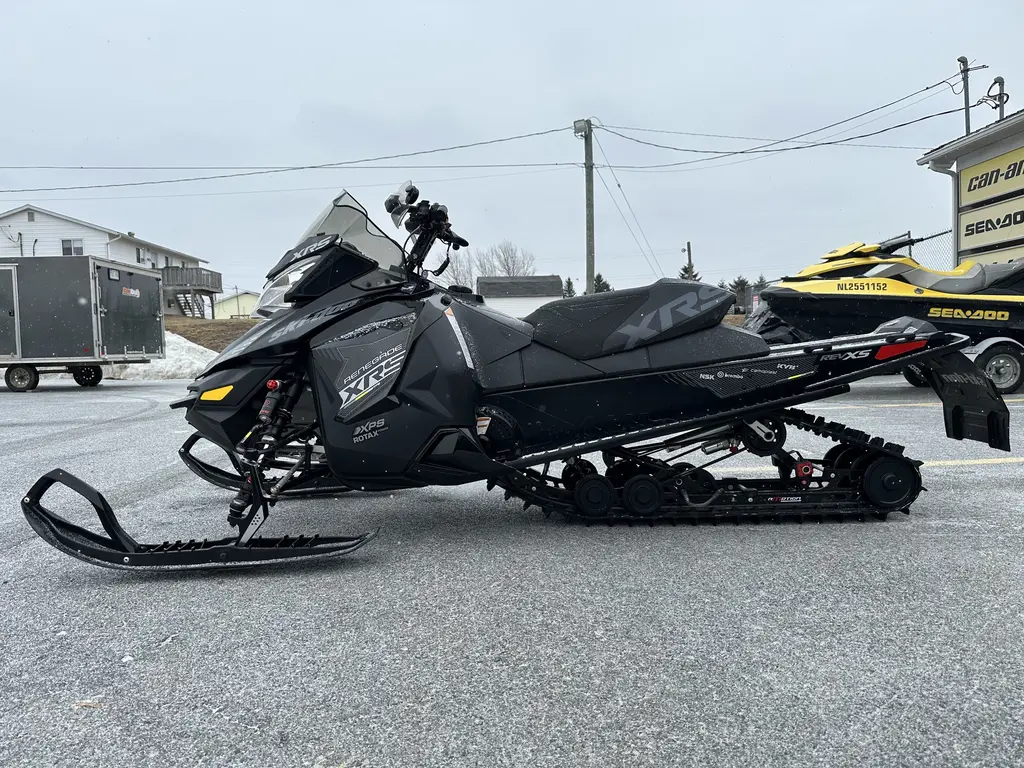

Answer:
[523,278,733,360]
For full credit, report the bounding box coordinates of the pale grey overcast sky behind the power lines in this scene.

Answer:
[0,0,1024,289]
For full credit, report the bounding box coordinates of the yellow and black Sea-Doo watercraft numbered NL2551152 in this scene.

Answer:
[743,237,1024,394]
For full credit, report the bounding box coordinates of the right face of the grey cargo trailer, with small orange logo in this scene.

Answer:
[93,262,163,357]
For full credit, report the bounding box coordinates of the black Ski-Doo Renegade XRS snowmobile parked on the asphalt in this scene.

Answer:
[22,185,1010,568]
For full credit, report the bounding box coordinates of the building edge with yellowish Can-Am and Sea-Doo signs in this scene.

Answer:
[918,110,1024,264]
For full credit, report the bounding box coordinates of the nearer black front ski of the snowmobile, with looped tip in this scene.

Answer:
[22,469,377,570]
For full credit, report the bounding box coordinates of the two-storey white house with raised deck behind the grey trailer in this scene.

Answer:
[0,205,221,317]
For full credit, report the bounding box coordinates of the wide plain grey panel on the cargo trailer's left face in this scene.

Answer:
[0,256,96,359]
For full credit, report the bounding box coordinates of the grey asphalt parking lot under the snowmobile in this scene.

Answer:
[0,377,1024,768]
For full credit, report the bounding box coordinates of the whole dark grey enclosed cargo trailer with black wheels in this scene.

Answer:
[0,256,165,392]
